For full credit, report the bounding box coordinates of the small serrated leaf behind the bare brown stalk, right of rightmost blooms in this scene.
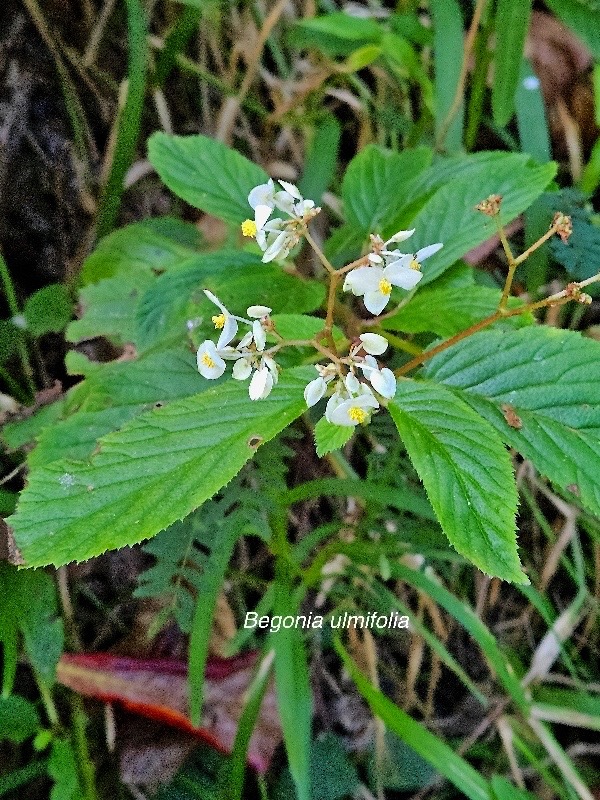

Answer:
[383,281,533,337]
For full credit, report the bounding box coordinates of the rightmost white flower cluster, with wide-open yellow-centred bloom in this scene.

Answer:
[343,229,443,315]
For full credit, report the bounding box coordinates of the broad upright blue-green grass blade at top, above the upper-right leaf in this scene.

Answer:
[431,0,464,150]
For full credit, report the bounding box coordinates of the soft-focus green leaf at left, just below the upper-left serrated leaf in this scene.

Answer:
[81,217,203,284]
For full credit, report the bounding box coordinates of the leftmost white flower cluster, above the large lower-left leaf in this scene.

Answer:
[196,289,278,400]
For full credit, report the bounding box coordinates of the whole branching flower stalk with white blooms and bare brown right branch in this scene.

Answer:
[197,180,598,427]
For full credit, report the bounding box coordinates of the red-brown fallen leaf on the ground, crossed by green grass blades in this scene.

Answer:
[56,652,281,773]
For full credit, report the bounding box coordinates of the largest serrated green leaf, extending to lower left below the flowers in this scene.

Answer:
[9,367,313,566]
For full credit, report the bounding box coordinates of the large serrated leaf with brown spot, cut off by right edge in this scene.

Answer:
[425,327,600,514]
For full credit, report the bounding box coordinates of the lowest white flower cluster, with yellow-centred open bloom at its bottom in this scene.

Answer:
[304,333,396,427]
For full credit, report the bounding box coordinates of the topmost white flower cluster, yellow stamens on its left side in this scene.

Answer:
[242,179,321,262]
